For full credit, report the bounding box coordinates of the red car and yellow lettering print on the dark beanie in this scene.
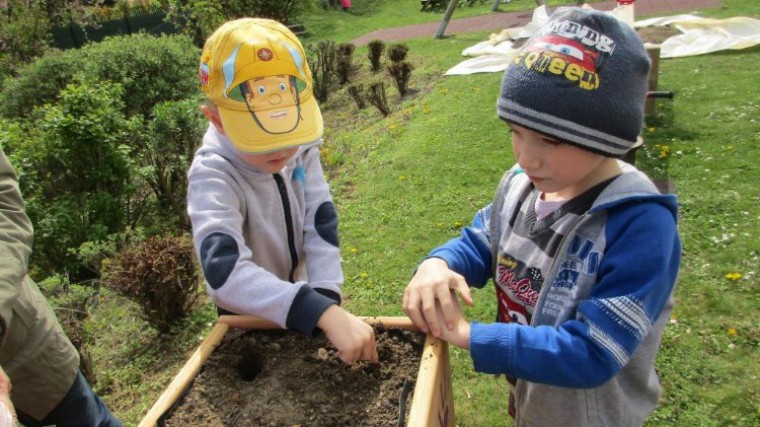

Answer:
[513,20,615,90]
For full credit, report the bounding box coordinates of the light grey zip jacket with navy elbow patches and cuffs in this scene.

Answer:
[187,125,343,335]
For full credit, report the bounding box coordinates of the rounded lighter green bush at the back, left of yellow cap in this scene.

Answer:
[0,34,200,118]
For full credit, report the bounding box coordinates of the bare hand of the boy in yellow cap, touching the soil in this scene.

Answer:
[317,305,379,363]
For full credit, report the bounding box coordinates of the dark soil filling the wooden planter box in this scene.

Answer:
[159,326,425,427]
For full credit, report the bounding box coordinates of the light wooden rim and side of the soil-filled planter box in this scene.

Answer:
[139,316,455,427]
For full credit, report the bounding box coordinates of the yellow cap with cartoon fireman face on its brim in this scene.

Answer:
[200,18,323,153]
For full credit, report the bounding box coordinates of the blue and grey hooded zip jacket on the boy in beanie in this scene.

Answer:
[430,163,681,427]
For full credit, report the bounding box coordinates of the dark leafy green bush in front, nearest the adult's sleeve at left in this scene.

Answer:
[7,83,141,280]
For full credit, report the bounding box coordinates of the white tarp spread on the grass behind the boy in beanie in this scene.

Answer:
[446,6,760,75]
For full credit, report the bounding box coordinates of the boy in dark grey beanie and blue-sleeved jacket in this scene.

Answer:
[403,8,681,427]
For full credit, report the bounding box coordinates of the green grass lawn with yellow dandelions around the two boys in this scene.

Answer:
[88,0,760,427]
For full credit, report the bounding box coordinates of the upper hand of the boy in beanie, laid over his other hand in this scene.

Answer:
[403,258,472,337]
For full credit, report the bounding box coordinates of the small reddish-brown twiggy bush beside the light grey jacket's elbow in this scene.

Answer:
[102,235,201,332]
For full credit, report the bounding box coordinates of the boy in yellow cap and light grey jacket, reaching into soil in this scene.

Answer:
[188,18,378,363]
